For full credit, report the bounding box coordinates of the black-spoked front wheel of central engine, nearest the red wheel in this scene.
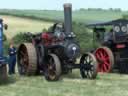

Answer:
[80,53,98,79]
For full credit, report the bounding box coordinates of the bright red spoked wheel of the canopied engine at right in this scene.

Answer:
[94,47,114,73]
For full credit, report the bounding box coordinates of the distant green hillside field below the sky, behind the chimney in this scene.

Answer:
[0,9,128,23]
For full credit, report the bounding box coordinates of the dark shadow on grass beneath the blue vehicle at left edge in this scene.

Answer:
[0,76,16,86]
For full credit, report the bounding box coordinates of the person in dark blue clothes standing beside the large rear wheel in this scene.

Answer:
[8,42,16,75]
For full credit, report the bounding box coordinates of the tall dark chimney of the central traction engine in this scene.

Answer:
[64,3,72,34]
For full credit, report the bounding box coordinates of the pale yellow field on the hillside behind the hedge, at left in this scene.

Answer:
[0,15,53,39]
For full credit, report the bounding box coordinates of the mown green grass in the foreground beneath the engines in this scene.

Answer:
[0,71,128,96]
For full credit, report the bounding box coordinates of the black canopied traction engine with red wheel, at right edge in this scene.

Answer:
[88,18,128,73]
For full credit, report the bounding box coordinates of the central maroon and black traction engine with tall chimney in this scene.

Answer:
[17,4,97,81]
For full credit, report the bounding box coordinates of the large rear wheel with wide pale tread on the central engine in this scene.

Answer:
[17,43,37,75]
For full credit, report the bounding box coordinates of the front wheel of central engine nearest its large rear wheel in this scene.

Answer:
[44,54,61,81]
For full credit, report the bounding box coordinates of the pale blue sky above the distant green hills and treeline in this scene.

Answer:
[0,0,128,10]
